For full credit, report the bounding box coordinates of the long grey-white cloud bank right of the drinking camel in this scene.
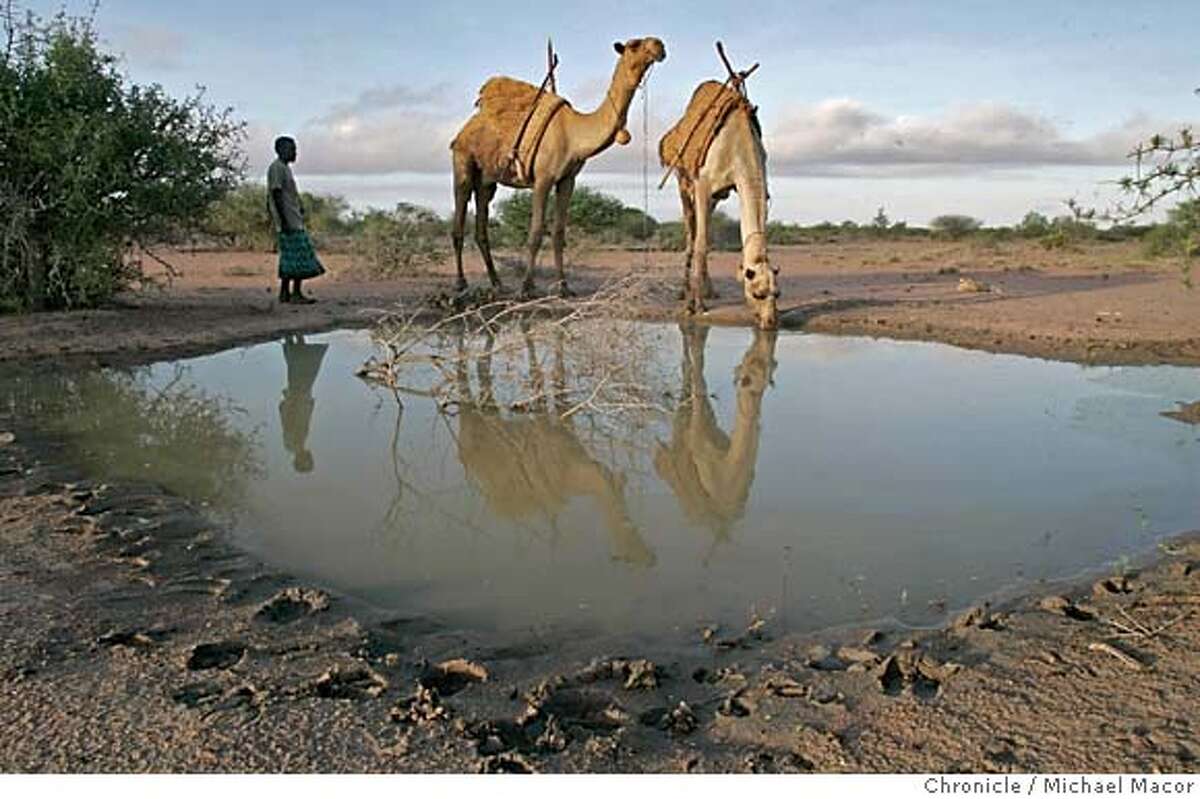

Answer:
[766,98,1172,176]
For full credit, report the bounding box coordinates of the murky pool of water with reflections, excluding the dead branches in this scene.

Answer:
[2,326,1200,641]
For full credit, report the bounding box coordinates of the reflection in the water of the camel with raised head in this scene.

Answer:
[456,326,655,566]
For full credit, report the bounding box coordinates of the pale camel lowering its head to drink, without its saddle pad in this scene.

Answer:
[660,82,779,330]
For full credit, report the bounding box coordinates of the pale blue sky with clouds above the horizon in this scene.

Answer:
[19,0,1200,224]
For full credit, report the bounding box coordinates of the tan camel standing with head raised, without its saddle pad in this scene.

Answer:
[450,37,667,296]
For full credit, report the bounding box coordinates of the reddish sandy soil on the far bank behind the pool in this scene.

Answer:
[0,240,1200,364]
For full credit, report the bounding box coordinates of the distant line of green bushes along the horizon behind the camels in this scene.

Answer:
[197,184,1200,275]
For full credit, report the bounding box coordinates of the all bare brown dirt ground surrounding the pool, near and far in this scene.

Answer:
[0,236,1200,773]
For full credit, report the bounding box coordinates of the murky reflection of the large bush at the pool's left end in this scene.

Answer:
[0,367,262,503]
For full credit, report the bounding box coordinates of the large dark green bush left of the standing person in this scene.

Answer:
[0,8,242,308]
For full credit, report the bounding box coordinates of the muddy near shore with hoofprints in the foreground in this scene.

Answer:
[0,395,1200,771]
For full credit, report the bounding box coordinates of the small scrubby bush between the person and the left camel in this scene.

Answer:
[349,203,450,276]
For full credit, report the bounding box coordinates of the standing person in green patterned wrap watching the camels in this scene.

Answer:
[266,136,325,305]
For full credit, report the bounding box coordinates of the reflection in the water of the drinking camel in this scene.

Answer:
[654,325,775,540]
